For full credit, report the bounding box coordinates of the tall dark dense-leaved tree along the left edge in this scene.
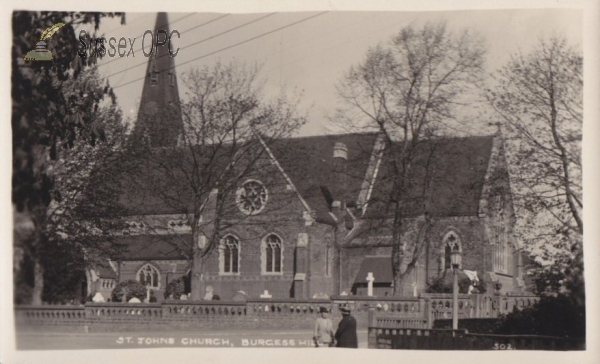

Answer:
[11,11,124,304]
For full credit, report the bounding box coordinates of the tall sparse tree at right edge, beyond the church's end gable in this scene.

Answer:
[488,38,583,300]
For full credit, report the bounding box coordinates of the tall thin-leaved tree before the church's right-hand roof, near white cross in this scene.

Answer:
[336,23,484,295]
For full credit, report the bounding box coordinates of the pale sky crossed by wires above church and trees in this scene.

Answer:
[91,9,583,135]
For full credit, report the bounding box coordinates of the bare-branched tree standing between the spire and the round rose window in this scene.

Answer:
[128,63,306,300]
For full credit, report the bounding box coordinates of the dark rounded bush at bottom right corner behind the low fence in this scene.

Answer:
[495,295,585,338]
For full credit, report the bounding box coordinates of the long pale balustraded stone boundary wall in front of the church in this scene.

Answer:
[15,294,537,332]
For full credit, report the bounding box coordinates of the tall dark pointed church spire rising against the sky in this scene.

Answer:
[131,13,183,148]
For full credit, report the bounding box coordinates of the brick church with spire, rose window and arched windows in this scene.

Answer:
[87,13,524,301]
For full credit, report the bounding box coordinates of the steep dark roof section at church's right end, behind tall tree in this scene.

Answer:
[364,136,494,218]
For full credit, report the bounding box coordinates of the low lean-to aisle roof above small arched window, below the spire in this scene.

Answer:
[113,234,192,261]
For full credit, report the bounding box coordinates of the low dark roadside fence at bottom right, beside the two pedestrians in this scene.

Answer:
[369,327,585,350]
